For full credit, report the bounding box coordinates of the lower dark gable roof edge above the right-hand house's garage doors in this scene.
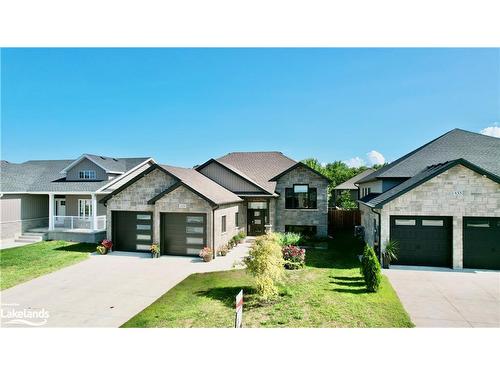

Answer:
[360,159,500,208]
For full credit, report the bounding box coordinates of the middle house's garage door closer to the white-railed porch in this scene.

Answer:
[111,211,153,252]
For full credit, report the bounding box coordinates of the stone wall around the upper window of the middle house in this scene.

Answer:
[274,166,328,237]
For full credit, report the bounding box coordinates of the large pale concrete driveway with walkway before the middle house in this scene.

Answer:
[1,242,250,327]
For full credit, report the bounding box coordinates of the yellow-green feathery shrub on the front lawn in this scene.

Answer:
[243,234,284,300]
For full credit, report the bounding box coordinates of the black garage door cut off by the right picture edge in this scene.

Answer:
[463,217,500,270]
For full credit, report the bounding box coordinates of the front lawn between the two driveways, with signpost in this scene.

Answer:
[124,234,413,327]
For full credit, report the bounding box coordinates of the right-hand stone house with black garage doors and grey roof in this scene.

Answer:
[358,129,500,269]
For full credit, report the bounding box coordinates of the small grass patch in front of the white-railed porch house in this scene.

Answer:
[0,241,96,290]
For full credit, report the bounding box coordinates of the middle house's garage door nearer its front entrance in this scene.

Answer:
[160,213,207,256]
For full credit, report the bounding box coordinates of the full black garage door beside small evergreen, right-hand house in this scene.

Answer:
[390,216,452,267]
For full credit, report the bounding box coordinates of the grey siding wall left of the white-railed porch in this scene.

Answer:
[0,194,49,239]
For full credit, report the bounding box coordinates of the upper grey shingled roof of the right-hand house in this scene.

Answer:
[358,129,500,183]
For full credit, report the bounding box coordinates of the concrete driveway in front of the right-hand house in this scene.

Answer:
[384,267,500,328]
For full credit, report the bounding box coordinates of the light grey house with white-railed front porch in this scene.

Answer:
[0,154,154,242]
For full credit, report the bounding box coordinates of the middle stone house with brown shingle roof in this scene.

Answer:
[101,152,329,255]
